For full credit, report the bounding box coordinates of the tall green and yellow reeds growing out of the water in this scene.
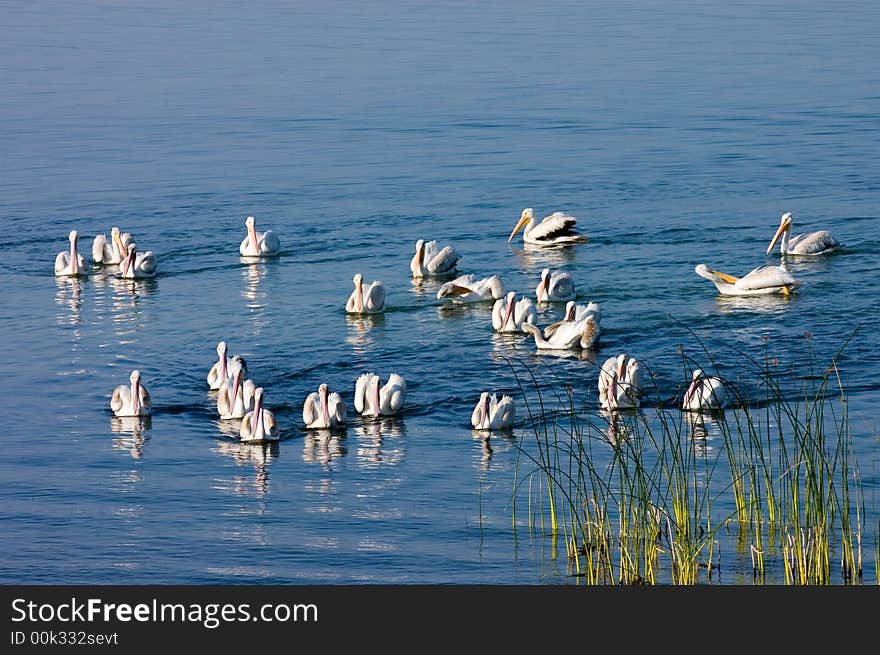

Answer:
[507,332,880,584]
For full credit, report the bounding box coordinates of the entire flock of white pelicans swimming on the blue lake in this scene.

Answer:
[55,208,840,443]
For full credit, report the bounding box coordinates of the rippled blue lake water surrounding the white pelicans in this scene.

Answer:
[0,0,880,584]
